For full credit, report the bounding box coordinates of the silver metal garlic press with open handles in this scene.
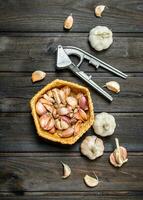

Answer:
[57,45,127,101]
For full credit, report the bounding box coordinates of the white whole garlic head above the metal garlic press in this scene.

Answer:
[89,26,113,51]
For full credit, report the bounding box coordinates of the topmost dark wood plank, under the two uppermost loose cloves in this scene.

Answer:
[0,0,143,32]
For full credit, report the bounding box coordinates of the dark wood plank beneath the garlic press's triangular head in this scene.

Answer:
[0,33,143,72]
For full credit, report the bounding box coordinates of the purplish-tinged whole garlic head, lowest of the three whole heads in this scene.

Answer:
[80,135,104,160]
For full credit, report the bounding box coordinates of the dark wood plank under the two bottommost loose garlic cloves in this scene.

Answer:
[0,154,143,193]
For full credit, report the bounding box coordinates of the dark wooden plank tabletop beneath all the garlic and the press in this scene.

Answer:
[0,0,143,200]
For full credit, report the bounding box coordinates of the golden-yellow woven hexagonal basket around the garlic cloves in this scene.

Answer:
[30,79,94,145]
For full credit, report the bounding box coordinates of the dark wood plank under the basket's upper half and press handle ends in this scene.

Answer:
[0,72,143,112]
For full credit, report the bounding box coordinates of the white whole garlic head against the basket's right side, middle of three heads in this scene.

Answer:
[93,112,116,137]
